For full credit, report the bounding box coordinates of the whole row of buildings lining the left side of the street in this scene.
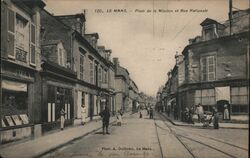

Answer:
[0,0,141,143]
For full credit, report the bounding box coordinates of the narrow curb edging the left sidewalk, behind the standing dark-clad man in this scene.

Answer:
[32,121,115,158]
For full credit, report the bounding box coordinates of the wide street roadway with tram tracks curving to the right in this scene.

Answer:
[40,111,248,158]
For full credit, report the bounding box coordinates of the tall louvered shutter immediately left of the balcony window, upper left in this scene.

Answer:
[7,9,15,57]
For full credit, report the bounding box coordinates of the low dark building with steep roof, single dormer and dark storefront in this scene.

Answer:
[37,10,76,132]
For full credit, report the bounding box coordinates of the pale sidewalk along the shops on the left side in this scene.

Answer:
[0,114,129,158]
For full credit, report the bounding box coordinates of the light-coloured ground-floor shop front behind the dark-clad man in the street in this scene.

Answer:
[74,83,116,124]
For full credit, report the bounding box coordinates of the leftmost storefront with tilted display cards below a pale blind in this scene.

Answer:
[0,62,35,143]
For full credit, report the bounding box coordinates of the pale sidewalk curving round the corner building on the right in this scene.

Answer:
[161,113,249,129]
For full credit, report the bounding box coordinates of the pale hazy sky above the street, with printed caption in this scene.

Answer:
[44,0,249,96]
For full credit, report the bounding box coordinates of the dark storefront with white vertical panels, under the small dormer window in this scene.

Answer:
[40,62,76,132]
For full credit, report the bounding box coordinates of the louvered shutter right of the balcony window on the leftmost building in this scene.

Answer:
[30,24,36,65]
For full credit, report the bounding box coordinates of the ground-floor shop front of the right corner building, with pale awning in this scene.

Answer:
[177,80,249,120]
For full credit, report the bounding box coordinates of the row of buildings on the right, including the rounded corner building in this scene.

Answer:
[157,9,250,120]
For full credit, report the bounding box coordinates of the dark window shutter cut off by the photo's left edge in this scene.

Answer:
[1,2,8,58]
